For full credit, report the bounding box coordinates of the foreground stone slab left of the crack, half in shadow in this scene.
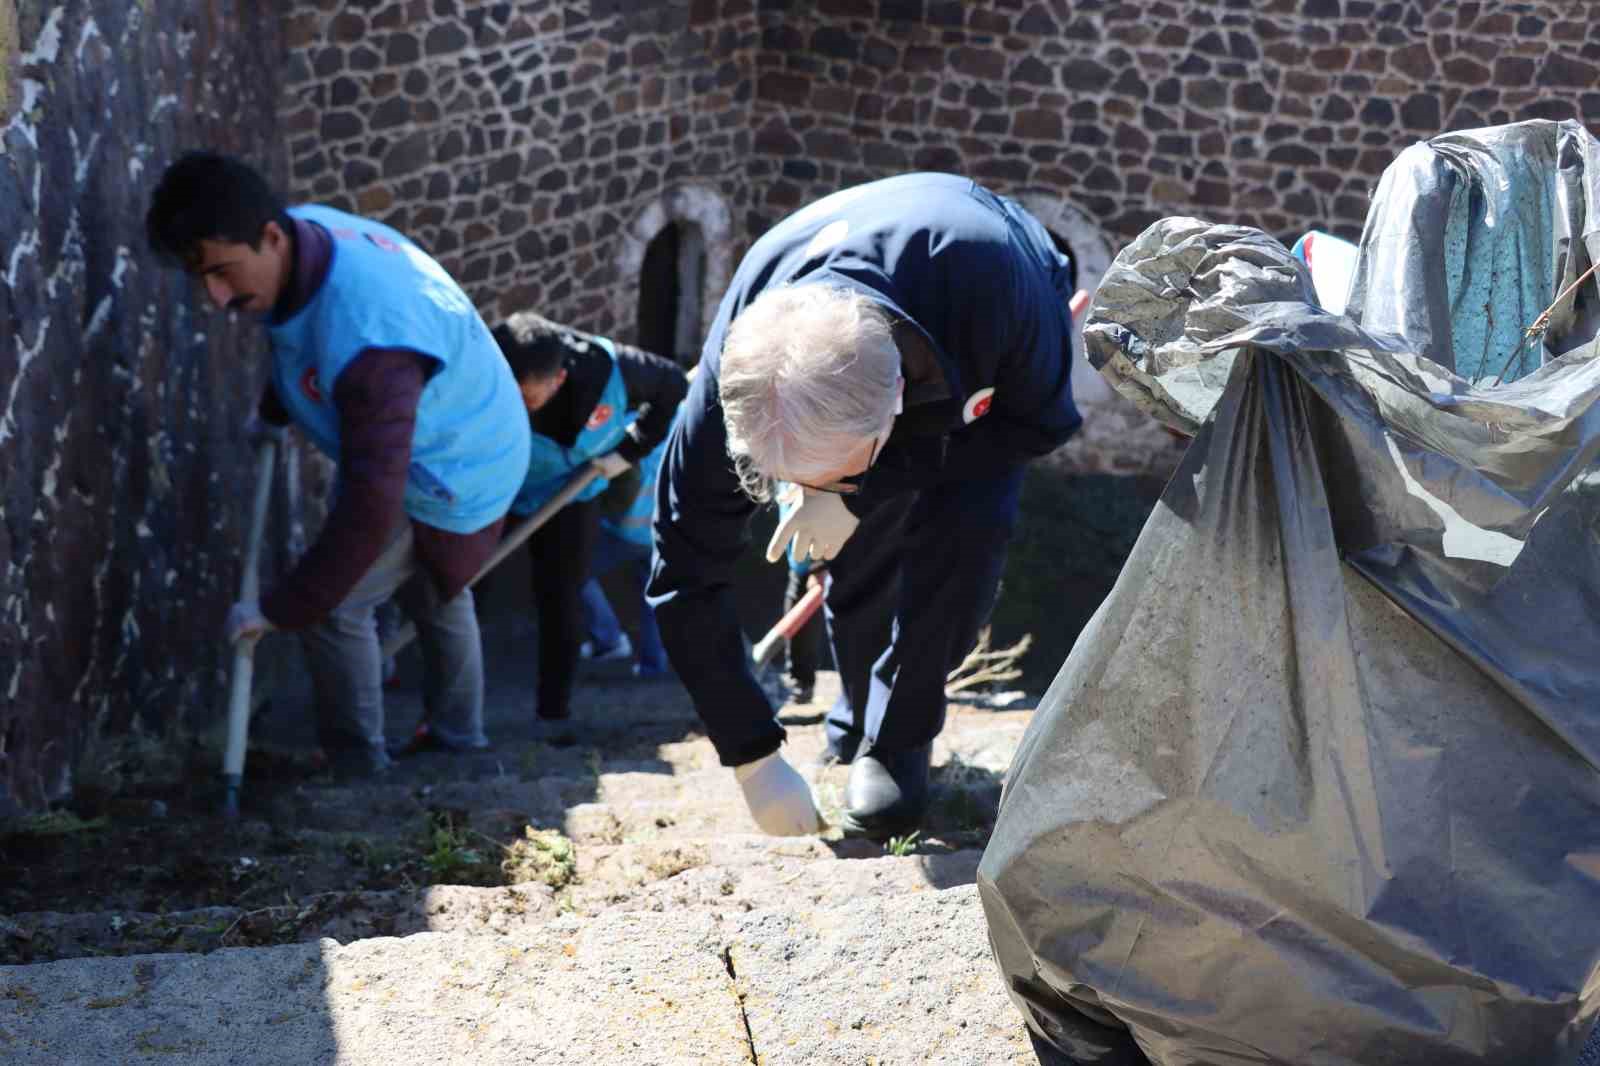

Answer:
[0,914,749,1066]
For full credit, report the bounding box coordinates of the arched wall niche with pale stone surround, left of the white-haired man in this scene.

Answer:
[618,186,733,367]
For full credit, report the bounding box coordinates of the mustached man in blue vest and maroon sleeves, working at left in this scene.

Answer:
[146,152,530,775]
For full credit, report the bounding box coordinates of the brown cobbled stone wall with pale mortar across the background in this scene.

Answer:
[285,0,1600,474]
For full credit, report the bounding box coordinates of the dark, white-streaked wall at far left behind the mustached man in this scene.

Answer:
[0,0,286,812]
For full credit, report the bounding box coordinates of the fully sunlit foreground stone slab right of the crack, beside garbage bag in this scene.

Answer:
[728,885,1038,1066]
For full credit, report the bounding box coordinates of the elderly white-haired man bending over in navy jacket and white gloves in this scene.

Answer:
[650,174,1080,836]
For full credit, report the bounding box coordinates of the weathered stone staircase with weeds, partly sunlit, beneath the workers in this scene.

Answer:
[0,611,1037,1066]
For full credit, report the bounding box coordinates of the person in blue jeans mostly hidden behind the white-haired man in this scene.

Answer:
[579,428,672,680]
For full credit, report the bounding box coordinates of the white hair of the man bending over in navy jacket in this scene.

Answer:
[718,283,901,501]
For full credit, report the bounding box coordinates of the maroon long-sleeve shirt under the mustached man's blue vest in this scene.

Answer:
[261,219,506,629]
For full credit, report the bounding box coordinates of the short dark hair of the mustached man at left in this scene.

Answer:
[144,152,290,266]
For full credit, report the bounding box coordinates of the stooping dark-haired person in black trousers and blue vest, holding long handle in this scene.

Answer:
[494,311,688,719]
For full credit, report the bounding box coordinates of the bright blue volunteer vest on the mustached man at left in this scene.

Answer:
[267,205,528,533]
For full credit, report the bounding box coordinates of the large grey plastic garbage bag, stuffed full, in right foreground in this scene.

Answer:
[978,123,1600,1066]
